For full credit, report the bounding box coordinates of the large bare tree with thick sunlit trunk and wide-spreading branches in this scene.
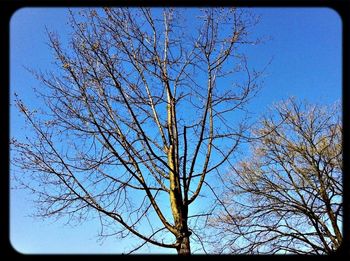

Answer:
[11,8,261,255]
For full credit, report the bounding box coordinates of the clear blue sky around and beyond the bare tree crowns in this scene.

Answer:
[10,8,342,253]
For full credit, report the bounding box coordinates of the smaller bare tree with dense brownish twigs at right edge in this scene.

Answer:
[212,99,343,254]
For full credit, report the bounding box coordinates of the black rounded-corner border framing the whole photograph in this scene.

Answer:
[0,0,350,259]
